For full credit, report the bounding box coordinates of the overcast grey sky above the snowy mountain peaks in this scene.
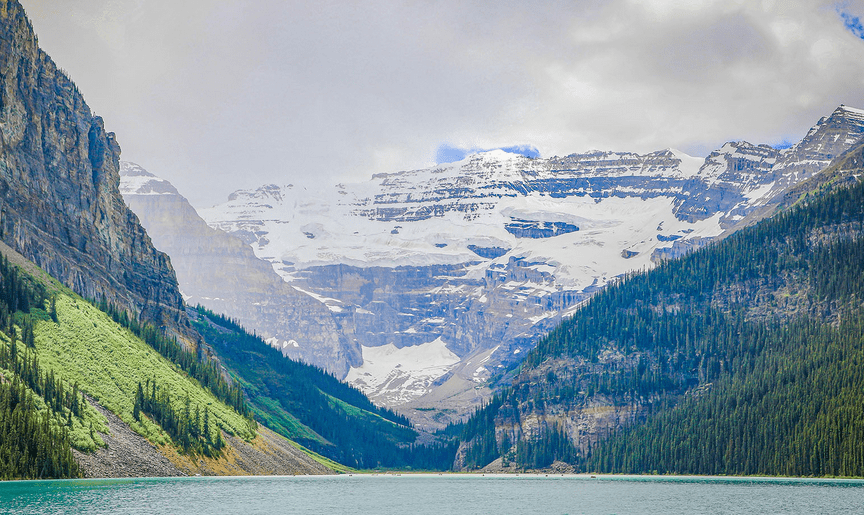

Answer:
[21,0,864,207]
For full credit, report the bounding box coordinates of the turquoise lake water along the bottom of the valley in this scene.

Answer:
[0,474,864,515]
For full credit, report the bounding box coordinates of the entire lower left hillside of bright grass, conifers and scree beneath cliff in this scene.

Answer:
[0,238,333,479]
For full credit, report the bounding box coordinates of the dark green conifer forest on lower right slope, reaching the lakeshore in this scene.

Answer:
[585,318,864,477]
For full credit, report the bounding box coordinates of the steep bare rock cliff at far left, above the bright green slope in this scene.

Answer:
[0,0,188,336]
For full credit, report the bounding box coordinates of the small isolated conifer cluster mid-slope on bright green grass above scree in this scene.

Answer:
[132,379,225,457]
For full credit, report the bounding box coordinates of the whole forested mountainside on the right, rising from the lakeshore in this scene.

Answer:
[451,145,864,476]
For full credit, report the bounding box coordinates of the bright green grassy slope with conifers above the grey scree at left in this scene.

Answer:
[0,252,256,478]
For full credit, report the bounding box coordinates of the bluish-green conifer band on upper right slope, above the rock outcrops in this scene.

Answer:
[524,175,864,366]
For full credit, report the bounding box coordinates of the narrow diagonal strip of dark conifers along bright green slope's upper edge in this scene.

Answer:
[94,297,254,424]
